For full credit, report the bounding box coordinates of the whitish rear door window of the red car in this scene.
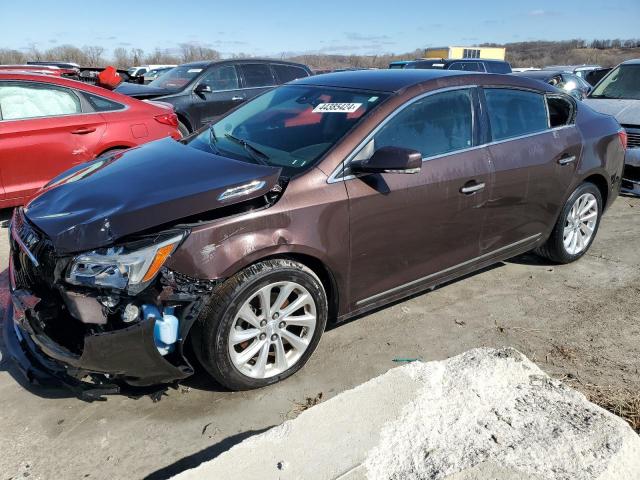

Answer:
[0,82,82,120]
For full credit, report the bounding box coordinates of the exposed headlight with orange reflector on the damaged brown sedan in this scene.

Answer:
[66,233,185,294]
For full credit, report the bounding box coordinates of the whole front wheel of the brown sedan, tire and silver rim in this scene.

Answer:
[191,259,328,390]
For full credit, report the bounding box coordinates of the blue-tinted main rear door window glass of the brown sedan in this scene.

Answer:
[484,88,548,141]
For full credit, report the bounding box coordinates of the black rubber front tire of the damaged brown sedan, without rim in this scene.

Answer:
[191,259,328,390]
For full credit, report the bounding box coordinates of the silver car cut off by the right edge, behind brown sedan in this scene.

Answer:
[584,59,640,196]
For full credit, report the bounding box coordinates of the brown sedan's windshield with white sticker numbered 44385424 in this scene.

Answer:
[189,85,388,176]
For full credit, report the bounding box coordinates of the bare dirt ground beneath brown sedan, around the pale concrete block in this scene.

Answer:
[0,197,640,480]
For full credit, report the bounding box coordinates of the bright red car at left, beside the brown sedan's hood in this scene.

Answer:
[0,69,180,208]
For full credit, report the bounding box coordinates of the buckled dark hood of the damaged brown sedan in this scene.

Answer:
[25,138,281,254]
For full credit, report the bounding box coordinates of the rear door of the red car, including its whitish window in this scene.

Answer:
[0,81,105,199]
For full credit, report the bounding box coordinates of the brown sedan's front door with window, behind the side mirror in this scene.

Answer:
[345,88,491,309]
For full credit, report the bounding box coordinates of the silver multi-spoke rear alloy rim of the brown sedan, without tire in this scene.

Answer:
[562,193,598,255]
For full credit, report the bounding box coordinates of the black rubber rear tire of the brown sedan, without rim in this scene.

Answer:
[535,182,602,264]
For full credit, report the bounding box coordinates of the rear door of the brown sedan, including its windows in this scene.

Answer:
[482,88,582,253]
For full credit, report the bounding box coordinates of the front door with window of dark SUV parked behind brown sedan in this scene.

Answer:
[190,64,246,129]
